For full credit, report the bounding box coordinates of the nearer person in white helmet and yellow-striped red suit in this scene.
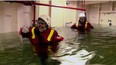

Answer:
[19,15,64,65]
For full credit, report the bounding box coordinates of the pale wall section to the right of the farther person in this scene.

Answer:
[87,1,116,26]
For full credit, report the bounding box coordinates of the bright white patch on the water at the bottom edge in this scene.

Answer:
[52,49,95,65]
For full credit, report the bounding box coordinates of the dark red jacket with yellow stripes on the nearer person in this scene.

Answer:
[29,27,59,53]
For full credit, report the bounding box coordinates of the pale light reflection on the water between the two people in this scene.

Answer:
[52,27,95,65]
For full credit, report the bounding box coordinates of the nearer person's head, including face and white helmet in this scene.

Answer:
[36,15,51,32]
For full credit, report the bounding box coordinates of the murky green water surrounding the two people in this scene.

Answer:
[0,26,116,65]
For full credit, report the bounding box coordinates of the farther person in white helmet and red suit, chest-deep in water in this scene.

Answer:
[71,13,93,34]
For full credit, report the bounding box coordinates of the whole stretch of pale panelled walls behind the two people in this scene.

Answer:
[0,0,116,33]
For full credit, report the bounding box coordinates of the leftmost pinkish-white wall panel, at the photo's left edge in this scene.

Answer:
[0,2,17,33]
